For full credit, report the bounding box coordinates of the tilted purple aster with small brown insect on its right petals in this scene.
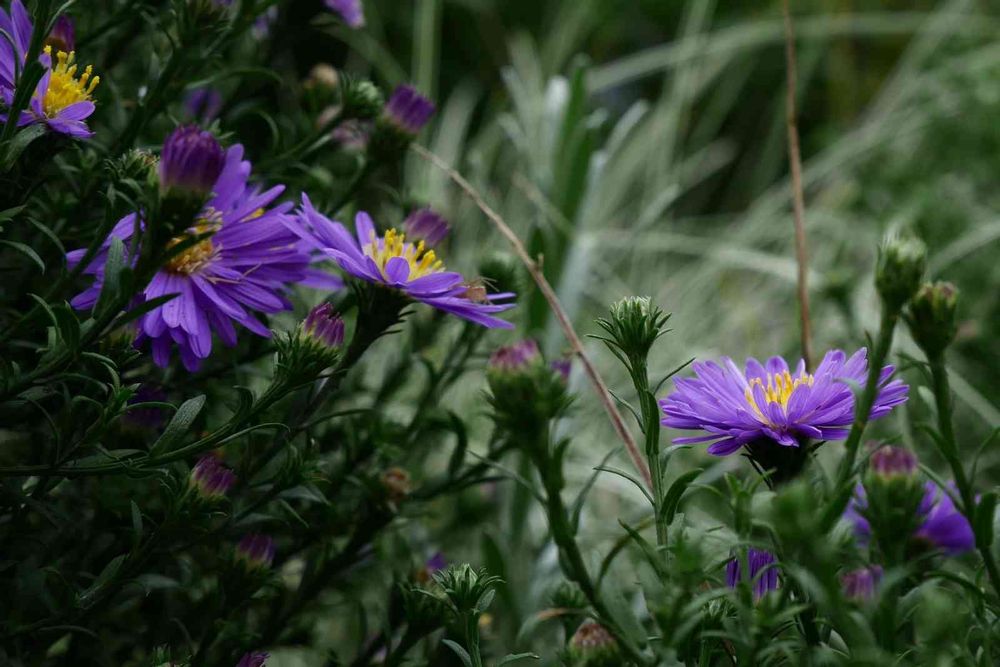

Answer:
[290,195,514,329]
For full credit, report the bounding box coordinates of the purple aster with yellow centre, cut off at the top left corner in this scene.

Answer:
[0,0,100,138]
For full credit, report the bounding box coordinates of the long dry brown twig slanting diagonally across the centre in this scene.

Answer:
[412,144,652,488]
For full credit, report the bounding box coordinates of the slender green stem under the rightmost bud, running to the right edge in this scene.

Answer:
[927,352,1000,595]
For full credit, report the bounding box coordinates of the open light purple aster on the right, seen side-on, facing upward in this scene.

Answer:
[660,348,907,456]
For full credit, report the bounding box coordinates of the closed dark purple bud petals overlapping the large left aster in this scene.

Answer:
[160,125,226,196]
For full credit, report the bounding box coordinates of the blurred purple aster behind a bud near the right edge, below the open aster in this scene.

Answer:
[844,481,976,555]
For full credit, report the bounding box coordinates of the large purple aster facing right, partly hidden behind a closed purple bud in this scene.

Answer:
[67,145,332,371]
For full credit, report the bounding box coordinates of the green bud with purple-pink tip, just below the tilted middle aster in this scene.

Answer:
[275,303,344,385]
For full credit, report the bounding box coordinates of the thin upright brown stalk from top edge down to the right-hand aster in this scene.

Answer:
[782,0,812,369]
